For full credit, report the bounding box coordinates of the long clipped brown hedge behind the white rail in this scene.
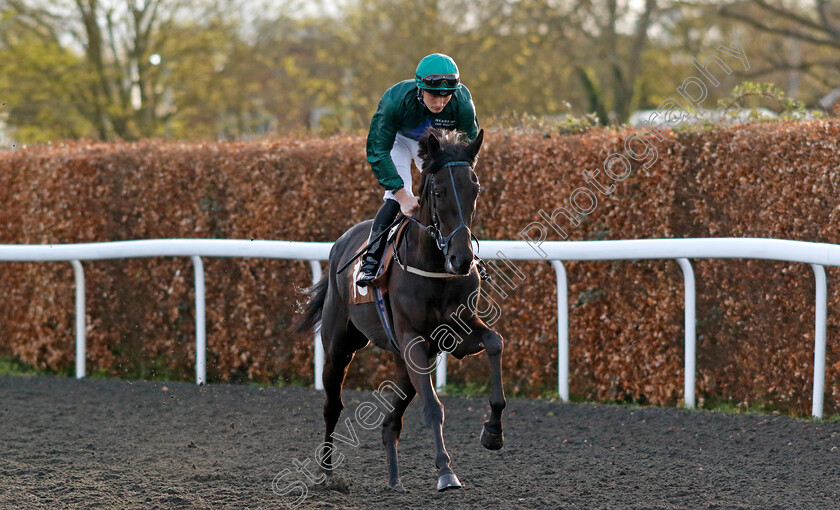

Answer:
[0,120,840,414]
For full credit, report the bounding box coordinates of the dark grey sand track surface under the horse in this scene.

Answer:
[0,376,840,510]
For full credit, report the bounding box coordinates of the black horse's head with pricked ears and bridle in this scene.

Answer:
[420,128,484,274]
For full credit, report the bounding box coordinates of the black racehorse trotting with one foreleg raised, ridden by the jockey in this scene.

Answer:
[298,129,505,491]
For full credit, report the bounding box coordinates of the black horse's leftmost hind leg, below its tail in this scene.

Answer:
[320,312,368,475]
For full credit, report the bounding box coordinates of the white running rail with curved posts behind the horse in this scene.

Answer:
[0,238,840,417]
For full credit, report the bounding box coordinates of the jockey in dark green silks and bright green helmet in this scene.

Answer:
[356,53,478,287]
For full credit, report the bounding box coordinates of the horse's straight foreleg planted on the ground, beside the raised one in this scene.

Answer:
[402,335,461,491]
